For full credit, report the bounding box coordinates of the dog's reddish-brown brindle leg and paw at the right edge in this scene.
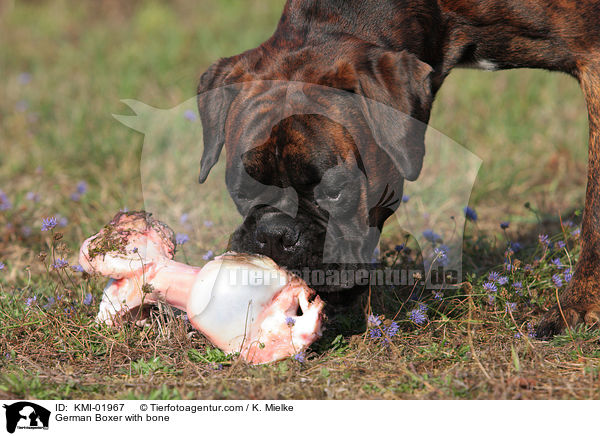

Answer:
[537,59,600,338]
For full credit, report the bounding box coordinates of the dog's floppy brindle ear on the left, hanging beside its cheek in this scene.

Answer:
[198,58,243,183]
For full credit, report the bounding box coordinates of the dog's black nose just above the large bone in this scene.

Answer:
[256,212,300,259]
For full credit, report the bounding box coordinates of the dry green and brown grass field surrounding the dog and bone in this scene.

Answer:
[0,0,600,399]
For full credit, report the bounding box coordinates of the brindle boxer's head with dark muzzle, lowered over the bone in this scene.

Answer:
[198,40,432,302]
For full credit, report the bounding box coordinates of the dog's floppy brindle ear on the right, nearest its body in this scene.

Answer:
[357,48,433,181]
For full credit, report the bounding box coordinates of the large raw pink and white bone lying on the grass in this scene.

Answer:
[79,212,324,364]
